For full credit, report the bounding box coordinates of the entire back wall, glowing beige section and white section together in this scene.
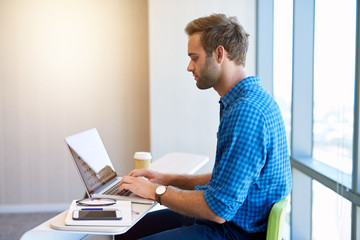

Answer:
[0,0,256,211]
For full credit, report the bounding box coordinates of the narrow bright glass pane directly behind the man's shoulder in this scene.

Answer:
[273,0,293,153]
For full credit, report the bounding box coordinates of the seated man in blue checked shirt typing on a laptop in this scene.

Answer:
[118,14,292,239]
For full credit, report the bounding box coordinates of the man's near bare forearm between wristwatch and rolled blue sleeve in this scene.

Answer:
[161,187,226,223]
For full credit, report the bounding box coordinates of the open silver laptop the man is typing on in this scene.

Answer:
[65,128,154,204]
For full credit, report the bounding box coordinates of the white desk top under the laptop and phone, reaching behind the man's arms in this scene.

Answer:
[21,153,209,240]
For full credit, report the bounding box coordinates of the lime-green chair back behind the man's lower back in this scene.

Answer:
[266,197,289,240]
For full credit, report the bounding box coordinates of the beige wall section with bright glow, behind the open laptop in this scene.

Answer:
[0,0,150,206]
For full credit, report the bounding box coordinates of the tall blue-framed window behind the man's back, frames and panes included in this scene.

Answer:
[257,0,360,240]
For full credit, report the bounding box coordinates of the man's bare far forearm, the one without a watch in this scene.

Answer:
[165,173,211,190]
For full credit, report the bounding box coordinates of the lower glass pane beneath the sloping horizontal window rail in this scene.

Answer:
[312,180,351,240]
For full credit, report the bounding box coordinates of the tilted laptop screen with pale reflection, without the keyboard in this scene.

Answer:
[65,128,117,194]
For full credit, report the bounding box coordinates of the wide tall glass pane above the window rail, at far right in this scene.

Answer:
[313,0,356,174]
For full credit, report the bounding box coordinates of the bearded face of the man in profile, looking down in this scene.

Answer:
[187,33,220,89]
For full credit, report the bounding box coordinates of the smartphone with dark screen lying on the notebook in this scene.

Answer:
[73,210,122,220]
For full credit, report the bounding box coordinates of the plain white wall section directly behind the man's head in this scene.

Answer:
[149,0,256,171]
